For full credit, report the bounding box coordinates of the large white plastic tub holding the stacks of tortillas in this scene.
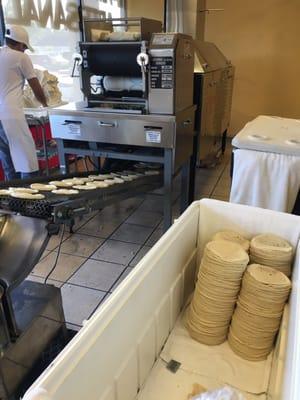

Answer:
[25,200,300,400]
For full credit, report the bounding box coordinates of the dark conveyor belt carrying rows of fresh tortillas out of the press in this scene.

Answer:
[0,171,162,223]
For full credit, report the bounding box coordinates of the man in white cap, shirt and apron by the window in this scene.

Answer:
[0,26,47,180]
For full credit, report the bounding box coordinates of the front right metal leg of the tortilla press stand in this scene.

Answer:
[164,149,173,231]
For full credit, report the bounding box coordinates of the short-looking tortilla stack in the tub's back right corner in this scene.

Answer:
[250,233,293,276]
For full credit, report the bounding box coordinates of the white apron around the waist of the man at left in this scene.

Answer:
[1,113,39,172]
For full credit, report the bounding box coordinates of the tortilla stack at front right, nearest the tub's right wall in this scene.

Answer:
[228,264,291,361]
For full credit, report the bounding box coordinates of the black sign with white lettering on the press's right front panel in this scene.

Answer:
[150,57,173,89]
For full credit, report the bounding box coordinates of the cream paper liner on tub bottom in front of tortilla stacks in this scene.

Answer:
[161,314,272,394]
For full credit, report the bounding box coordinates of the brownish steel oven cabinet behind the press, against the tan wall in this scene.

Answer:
[194,41,234,165]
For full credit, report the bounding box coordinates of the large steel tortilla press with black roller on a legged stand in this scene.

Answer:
[49,18,195,229]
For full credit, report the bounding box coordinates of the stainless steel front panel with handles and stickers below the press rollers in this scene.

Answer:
[50,106,176,148]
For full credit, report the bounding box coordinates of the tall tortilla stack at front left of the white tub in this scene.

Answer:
[186,240,249,345]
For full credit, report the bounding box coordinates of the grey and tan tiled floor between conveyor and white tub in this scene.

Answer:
[29,149,230,330]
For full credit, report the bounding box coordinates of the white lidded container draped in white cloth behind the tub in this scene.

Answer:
[230,116,300,213]
